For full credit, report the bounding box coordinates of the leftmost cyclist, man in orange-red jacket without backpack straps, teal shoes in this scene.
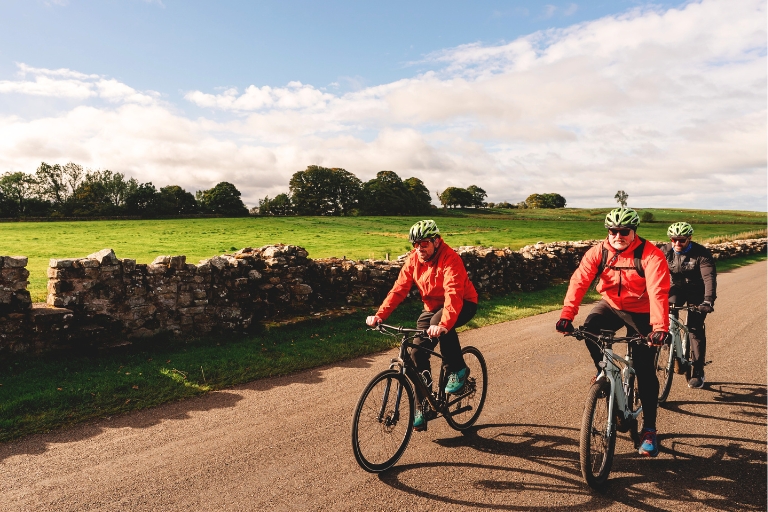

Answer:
[366,220,477,431]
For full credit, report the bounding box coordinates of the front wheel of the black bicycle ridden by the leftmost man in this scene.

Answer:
[352,370,415,473]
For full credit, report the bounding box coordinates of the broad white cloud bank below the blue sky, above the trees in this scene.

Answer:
[0,0,767,210]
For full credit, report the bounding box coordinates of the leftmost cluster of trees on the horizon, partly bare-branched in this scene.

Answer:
[0,162,248,218]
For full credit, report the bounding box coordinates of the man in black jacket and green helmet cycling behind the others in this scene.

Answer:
[662,222,717,389]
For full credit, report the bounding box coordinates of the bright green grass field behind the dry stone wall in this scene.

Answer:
[0,208,766,302]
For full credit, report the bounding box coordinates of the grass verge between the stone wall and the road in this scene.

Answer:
[0,255,766,441]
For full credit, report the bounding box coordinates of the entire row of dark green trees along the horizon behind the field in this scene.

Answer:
[0,162,566,218]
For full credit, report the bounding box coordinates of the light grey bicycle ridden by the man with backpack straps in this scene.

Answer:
[568,326,645,489]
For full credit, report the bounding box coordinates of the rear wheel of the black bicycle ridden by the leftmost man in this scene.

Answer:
[443,347,488,431]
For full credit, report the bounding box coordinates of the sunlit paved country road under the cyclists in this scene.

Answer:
[0,262,767,511]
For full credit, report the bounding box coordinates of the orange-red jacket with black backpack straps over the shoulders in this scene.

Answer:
[560,236,670,331]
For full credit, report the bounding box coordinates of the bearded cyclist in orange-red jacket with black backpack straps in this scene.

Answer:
[555,207,670,457]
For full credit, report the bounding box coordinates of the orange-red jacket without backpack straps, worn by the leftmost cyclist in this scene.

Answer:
[376,241,476,330]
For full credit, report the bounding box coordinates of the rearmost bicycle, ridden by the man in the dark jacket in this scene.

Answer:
[655,305,712,403]
